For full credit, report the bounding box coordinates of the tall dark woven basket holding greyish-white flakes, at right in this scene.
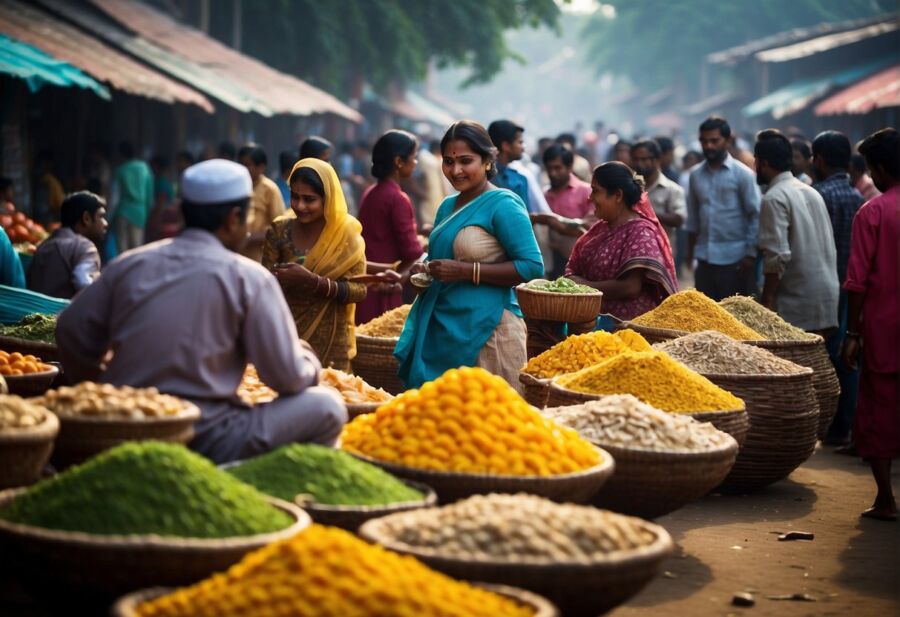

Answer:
[705,369,819,491]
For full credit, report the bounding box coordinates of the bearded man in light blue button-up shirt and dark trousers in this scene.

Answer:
[685,116,760,301]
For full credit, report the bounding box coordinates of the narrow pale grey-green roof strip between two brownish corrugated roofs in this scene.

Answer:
[38,0,274,116]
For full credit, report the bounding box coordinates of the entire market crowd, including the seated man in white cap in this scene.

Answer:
[0,116,900,519]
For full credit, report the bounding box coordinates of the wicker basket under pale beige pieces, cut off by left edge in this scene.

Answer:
[0,412,59,488]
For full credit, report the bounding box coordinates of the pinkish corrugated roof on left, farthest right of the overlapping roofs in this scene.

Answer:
[91,0,363,122]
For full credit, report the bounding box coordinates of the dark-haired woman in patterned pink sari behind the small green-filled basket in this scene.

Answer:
[566,161,678,320]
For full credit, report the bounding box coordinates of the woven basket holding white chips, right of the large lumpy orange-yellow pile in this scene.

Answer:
[591,438,738,518]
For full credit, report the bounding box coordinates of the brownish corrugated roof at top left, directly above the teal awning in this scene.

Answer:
[0,0,213,112]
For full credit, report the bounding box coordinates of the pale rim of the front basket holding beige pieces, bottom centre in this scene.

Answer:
[359,506,674,572]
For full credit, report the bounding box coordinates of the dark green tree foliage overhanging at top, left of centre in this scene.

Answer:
[242,0,560,95]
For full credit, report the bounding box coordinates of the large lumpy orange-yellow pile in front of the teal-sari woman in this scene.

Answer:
[341,367,600,476]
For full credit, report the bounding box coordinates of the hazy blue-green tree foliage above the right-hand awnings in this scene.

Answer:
[583,0,893,89]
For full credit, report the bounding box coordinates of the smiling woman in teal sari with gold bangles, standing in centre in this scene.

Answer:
[394,120,544,389]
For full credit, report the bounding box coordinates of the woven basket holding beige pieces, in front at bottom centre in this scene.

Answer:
[359,513,673,617]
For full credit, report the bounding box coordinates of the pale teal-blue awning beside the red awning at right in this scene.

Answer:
[741,58,895,120]
